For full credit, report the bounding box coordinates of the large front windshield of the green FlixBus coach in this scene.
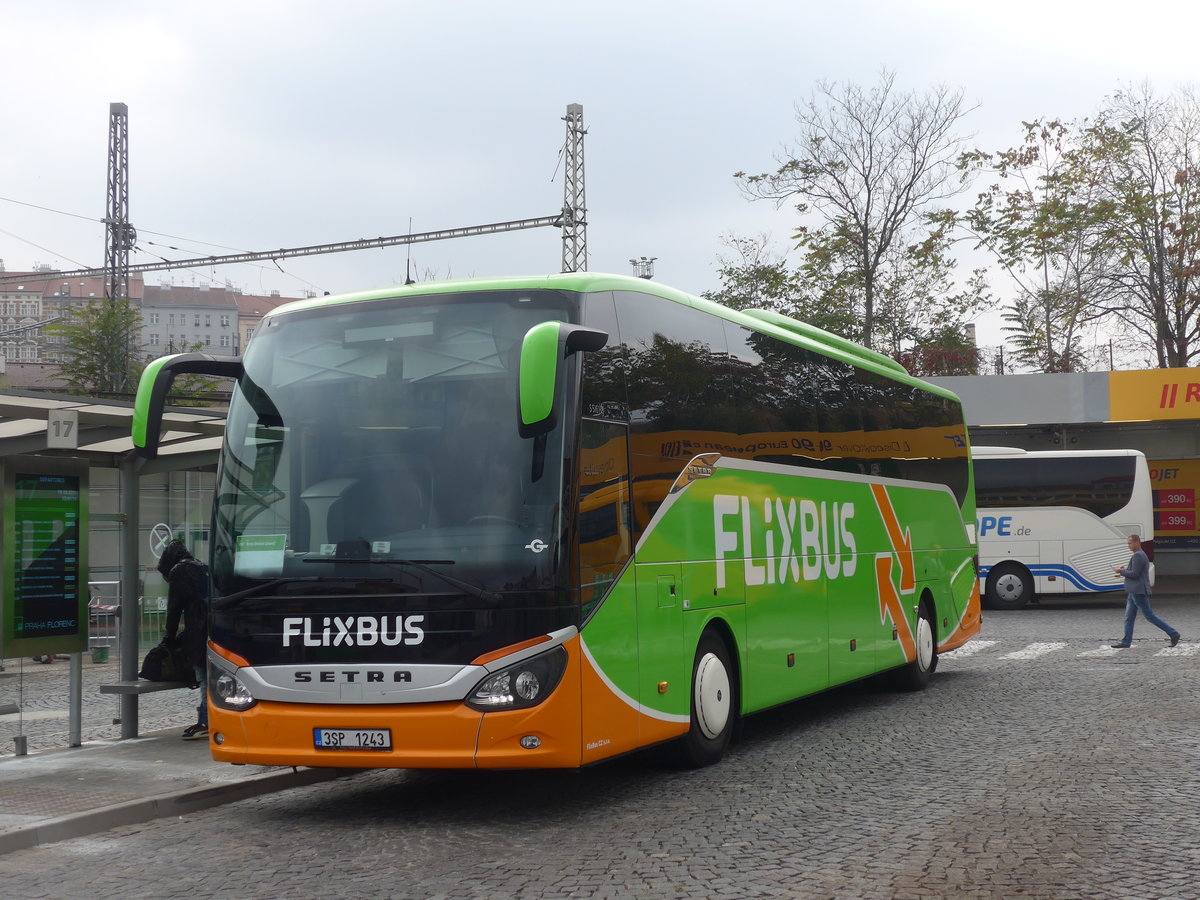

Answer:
[214,290,572,596]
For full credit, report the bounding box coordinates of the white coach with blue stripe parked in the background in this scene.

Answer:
[971,446,1154,610]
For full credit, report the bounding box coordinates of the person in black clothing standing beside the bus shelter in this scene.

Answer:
[158,539,209,740]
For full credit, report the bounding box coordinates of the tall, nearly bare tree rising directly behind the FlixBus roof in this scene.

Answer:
[734,71,966,347]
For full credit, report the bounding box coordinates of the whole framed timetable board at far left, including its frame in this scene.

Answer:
[2,458,88,656]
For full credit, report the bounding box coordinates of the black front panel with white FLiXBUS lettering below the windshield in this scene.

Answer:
[211,592,580,666]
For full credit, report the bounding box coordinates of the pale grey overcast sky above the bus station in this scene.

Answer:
[0,0,1200,343]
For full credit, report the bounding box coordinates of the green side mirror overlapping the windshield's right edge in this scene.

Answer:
[517,322,608,438]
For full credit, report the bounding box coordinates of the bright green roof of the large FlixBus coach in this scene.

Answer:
[265,272,959,402]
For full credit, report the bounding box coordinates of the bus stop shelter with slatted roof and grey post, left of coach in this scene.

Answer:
[0,392,226,743]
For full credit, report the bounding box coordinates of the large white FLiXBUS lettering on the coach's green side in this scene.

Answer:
[713,493,858,588]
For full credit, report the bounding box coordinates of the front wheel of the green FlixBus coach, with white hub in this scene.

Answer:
[676,629,738,769]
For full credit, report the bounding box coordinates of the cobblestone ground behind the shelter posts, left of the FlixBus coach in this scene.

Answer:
[0,654,199,757]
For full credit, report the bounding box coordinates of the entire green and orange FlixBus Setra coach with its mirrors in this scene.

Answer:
[134,272,980,768]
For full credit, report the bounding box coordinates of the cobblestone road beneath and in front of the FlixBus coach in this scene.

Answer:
[0,599,1200,900]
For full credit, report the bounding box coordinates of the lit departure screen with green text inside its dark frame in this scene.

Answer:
[7,473,82,638]
